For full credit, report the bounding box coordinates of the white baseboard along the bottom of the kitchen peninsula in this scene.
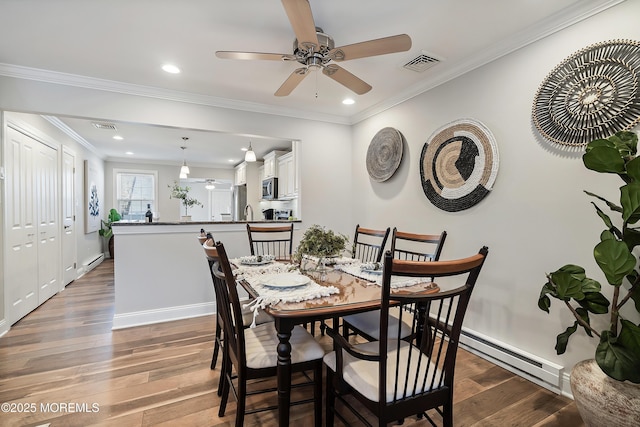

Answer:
[111,302,216,330]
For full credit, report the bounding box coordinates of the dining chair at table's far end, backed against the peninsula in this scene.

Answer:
[247,223,293,261]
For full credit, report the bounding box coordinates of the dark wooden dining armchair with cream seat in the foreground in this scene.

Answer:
[324,246,488,427]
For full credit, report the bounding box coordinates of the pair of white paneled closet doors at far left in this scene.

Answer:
[4,126,61,324]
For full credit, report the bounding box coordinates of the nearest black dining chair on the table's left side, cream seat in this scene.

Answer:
[211,242,324,427]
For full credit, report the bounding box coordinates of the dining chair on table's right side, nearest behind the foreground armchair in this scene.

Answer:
[342,227,447,341]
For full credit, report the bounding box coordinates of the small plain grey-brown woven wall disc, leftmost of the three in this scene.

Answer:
[367,128,403,182]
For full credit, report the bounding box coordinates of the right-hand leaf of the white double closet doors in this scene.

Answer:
[36,140,61,304]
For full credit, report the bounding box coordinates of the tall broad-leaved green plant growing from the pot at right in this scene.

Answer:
[538,131,640,383]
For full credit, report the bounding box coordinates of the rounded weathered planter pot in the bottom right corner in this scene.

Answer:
[570,359,640,427]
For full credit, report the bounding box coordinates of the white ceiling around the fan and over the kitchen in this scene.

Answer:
[0,0,621,167]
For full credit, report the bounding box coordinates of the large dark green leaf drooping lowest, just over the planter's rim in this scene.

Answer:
[596,331,640,383]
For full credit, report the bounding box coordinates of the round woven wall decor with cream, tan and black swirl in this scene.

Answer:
[420,119,498,212]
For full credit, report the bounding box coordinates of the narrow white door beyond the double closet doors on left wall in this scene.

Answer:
[61,148,78,286]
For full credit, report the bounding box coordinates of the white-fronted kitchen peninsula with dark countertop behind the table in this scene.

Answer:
[113,220,301,329]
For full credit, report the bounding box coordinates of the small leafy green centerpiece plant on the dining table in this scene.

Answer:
[294,224,349,269]
